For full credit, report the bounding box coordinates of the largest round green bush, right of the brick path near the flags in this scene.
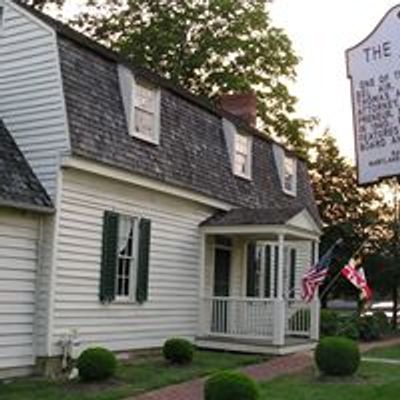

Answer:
[315,337,360,376]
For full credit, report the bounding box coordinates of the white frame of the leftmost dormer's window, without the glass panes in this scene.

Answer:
[130,80,161,144]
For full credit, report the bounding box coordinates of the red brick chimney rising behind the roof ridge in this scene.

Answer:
[218,92,257,127]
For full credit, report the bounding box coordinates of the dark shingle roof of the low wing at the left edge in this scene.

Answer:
[0,119,52,211]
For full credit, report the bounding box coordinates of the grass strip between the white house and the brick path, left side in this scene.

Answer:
[0,351,266,400]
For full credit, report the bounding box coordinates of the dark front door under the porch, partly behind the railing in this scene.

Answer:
[212,247,231,333]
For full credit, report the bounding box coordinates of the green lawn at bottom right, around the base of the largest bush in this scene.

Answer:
[261,362,400,400]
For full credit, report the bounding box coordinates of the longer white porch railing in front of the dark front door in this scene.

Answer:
[201,297,274,339]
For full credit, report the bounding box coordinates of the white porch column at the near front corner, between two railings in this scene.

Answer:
[272,234,286,346]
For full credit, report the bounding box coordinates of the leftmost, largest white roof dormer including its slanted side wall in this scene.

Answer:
[118,65,160,144]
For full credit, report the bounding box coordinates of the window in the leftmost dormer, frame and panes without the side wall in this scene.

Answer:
[134,81,159,142]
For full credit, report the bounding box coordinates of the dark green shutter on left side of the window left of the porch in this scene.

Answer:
[100,211,118,303]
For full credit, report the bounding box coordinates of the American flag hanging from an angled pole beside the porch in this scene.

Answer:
[301,239,342,303]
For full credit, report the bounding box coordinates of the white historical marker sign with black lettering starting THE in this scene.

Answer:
[346,6,400,184]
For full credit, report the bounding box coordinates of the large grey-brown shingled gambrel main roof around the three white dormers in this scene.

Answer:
[14,0,320,224]
